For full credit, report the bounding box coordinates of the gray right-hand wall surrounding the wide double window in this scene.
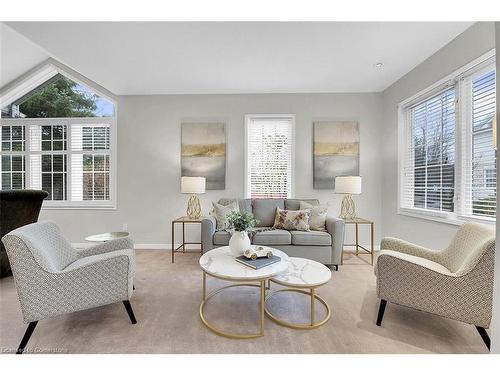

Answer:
[381,22,495,248]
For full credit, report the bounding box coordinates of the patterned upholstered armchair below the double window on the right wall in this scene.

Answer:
[375,223,495,349]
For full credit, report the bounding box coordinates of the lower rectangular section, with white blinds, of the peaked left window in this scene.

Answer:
[0,118,115,207]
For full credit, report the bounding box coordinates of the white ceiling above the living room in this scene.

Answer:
[2,22,472,95]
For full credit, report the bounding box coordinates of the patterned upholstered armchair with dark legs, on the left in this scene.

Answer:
[2,222,136,354]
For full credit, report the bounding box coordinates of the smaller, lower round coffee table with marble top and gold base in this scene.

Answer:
[265,257,332,329]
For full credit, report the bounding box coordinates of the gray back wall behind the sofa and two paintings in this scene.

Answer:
[41,93,382,244]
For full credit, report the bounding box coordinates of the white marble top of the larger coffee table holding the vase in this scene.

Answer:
[200,246,290,281]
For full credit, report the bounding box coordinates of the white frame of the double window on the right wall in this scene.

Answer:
[397,50,498,225]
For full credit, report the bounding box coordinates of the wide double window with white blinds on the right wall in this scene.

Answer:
[399,54,496,225]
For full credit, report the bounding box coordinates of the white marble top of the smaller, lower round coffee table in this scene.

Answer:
[272,257,332,288]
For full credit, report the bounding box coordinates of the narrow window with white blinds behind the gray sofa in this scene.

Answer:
[245,115,295,198]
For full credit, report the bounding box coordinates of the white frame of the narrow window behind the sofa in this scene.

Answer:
[243,114,295,199]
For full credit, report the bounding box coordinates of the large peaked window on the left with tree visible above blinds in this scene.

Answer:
[0,66,116,207]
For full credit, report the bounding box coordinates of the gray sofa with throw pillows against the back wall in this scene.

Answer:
[201,199,345,269]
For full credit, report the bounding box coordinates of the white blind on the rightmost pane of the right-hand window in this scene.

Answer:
[461,68,497,218]
